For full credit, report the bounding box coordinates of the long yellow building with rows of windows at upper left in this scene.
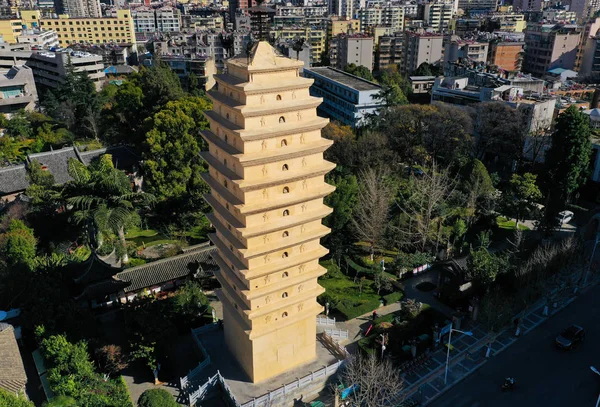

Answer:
[21,10,135,47]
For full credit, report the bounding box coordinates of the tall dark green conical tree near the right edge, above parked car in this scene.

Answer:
[545,105,592,226]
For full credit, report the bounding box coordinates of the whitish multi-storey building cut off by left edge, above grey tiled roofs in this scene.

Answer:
[0,65,38,115]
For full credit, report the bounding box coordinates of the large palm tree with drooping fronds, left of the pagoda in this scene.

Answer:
[63,154,155,263]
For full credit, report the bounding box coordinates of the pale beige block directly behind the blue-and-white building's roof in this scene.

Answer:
[330,34,374,70]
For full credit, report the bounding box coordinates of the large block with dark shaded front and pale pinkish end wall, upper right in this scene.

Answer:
[523,22,582,77]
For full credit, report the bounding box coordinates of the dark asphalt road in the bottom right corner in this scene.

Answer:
[428,286,600,407]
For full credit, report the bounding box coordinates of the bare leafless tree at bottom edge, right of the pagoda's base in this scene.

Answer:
[341,354,403,407]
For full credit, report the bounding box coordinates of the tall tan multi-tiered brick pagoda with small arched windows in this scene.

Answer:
[201,41,335,383]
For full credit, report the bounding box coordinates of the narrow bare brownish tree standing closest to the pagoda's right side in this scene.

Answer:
[352,168,394,260]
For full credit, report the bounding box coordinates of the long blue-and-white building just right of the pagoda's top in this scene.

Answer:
[304,67,384,127]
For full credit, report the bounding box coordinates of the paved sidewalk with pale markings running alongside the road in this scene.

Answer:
[404,276,600,406]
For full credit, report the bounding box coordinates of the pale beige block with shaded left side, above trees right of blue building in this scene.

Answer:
[401,31,444,74]
